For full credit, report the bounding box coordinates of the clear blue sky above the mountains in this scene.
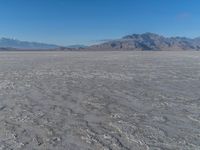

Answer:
[0,0,200,46]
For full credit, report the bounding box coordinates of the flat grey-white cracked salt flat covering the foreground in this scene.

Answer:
[0,52,200,150]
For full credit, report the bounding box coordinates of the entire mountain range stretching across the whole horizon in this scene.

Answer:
[0,32,200,51]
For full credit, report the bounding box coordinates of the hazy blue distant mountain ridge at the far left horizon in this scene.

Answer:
[0,38,60,50]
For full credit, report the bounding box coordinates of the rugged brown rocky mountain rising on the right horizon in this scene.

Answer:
[89,33,200,51]
